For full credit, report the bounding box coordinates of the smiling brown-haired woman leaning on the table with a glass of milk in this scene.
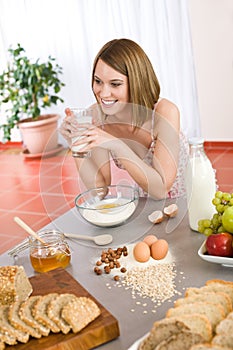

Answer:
[61,39,187,199]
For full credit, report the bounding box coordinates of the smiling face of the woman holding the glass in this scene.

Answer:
[93,59,129,115]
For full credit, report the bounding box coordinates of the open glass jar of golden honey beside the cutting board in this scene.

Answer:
[29,230,71,272]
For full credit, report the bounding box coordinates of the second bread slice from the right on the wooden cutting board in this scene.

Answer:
[47,293,77,334]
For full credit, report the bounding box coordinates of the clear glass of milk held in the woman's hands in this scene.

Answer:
[70,108,92,158]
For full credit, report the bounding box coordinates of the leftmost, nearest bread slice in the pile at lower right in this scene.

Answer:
[139,318,189,350]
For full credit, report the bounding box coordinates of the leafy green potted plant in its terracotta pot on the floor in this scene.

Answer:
[0,44,65,154]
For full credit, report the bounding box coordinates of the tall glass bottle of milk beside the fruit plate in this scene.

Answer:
[186,137,216,231]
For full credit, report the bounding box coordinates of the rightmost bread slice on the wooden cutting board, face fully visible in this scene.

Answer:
[61,297,100,333]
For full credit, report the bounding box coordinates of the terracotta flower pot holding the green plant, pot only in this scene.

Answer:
[18,114,60,154]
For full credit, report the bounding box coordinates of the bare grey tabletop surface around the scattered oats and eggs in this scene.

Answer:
[3,198,233,350]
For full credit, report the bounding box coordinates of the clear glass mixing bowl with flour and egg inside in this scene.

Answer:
[75,185,139,227]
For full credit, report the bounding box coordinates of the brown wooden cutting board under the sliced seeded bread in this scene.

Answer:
[6,268,120,350]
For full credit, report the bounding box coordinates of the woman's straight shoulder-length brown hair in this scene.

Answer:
[92,39,160,126]
